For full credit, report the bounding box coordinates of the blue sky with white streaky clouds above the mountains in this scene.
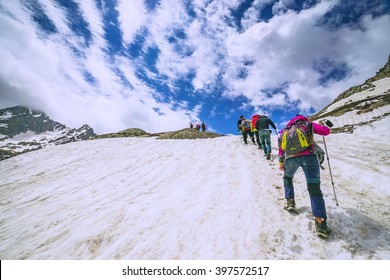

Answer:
[0,0,390,134]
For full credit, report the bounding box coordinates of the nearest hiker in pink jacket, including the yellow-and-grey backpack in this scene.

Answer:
[279,115,330,238]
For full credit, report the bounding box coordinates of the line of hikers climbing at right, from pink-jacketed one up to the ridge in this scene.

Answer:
[237,115,330,238]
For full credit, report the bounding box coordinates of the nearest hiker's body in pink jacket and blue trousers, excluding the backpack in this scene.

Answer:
[279,115,330,238]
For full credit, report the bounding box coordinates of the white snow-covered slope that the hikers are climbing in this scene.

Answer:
[0,115,390,260]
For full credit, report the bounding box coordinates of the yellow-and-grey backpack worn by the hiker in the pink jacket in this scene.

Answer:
[281,120,313,155]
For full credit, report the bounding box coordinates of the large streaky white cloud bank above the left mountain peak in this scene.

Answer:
[0,1,198,133]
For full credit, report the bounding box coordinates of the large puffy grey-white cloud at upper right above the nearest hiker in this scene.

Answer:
[221,1,390,109]
